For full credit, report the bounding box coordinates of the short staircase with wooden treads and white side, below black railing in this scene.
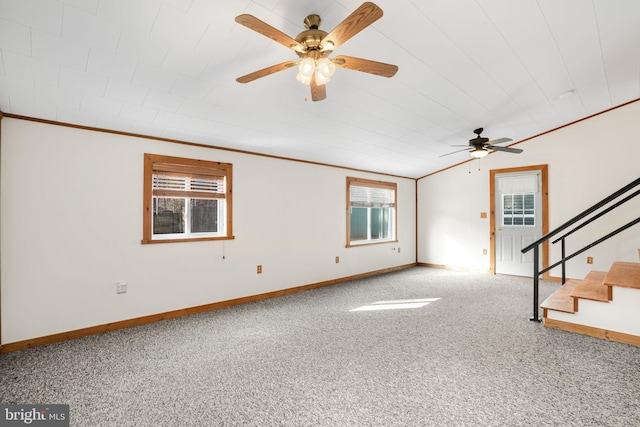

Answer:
[541,250,640,346]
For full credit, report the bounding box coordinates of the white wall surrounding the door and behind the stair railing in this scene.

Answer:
[418,102,640,278]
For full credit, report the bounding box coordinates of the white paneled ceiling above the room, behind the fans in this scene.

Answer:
[0,0,640,178]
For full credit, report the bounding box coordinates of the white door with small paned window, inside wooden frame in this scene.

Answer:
[494,171,542,277]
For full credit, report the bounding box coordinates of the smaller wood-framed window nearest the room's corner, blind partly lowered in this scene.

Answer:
[347,177,397,246]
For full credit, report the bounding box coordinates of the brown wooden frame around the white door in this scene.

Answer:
[489,165,549,280]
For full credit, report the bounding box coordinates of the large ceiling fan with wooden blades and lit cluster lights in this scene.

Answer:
[236,2,398,101]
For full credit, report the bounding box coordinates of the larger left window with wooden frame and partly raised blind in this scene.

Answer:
[142,154,233,243]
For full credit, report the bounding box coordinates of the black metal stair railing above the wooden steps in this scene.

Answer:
[521,178,640,322]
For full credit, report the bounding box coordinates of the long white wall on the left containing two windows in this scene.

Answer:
[0,117,416,343]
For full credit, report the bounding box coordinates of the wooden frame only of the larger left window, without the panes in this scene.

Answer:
[142,153,234,244]
